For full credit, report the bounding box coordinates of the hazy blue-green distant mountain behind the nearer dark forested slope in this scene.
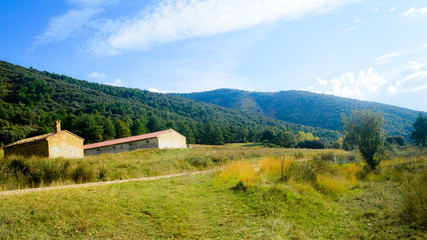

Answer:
[179,89,419,139]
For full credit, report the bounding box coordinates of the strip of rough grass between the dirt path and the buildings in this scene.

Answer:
[0,145,347,190]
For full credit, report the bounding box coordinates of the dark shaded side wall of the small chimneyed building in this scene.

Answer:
[3,140,49,157]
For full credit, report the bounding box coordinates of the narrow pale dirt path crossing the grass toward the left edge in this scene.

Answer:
[0,169,217,197]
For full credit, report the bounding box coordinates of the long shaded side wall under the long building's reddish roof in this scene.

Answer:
[84,138,159,156]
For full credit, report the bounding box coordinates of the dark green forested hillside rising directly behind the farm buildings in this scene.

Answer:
[0,61,341,147]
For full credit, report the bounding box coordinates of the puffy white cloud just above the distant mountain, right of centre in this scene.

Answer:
[306,67,387,99]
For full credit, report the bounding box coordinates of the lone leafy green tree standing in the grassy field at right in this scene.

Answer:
[341,110,385,170]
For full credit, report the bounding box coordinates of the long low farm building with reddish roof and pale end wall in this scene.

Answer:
[83,129,187,156]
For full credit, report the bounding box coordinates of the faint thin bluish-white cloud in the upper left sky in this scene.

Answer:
[35,8,103,46]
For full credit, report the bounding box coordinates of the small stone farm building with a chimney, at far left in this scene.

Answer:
[3,121,84,158]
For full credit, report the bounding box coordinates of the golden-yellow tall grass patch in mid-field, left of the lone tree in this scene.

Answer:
[219,156,362,196]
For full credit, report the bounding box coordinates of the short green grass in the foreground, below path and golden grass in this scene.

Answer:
[0,172,368,239]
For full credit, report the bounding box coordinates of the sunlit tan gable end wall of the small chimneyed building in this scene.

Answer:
[48,131,84,158]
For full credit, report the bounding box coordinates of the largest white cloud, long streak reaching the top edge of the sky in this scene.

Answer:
[88,0,357,55]
